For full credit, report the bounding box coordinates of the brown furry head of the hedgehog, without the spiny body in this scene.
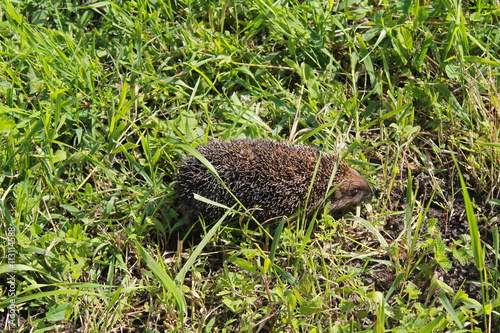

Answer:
[329,166,373,213]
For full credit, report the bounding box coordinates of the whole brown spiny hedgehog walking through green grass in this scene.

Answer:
[175,139,372,222]
